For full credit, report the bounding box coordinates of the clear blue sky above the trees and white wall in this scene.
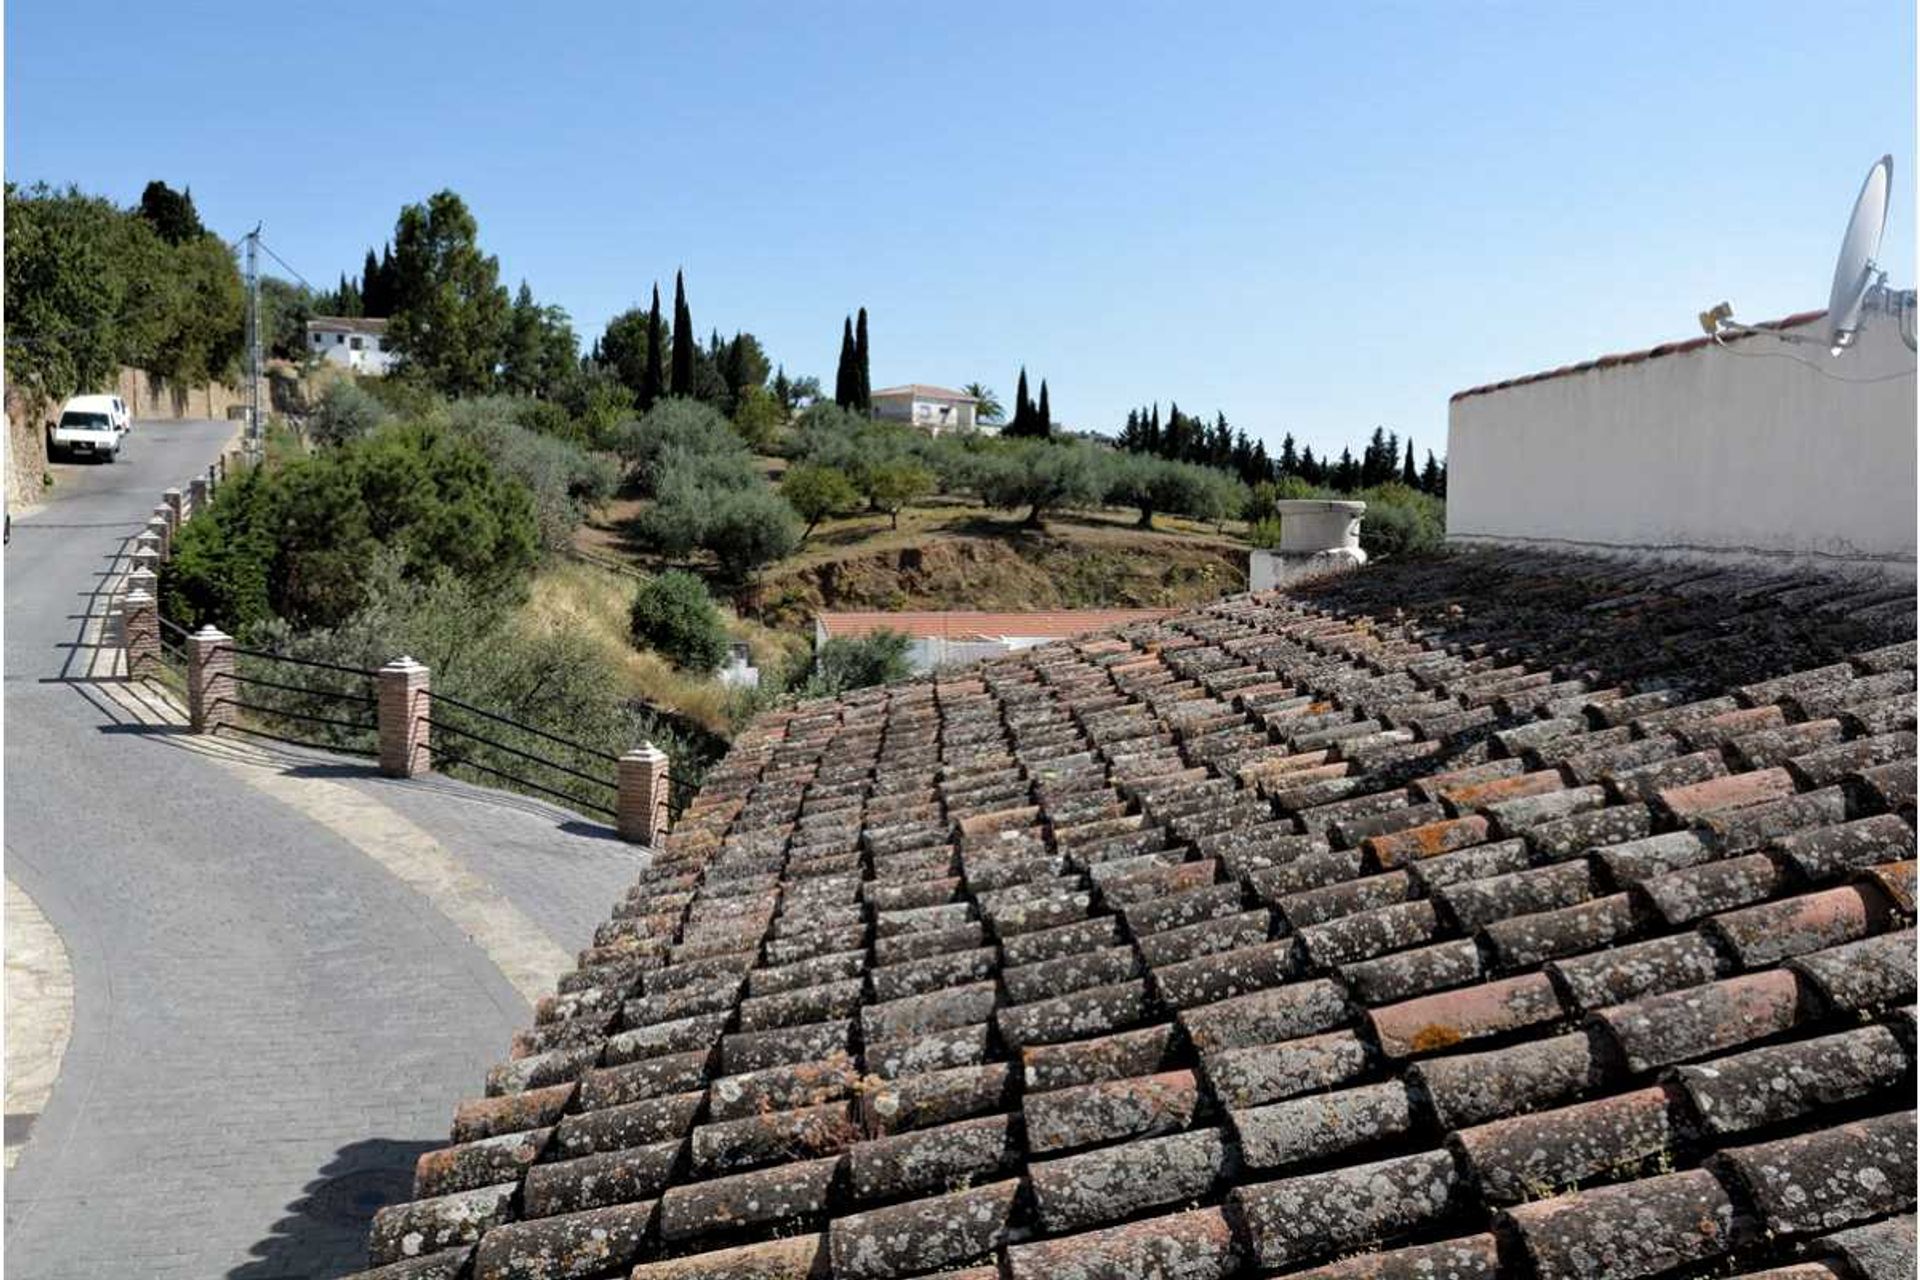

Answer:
[6,0,1914,462]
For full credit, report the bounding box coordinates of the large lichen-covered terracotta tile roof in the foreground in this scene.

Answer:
[353,553,1916,1280]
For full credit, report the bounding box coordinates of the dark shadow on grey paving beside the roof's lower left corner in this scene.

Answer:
[227,1138,433,1280]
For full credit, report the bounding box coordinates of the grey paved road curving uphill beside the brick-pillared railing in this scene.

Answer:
[4,422,637,1280]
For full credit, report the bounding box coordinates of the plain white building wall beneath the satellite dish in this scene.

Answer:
[1448,315,1914,576]
